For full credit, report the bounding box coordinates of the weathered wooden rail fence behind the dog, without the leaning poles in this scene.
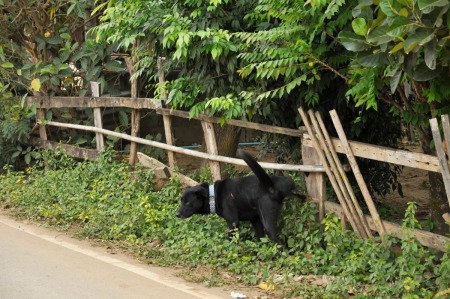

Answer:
[27,97,450,251]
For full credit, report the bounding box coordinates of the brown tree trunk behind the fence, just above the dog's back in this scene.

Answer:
[216,125,241,178]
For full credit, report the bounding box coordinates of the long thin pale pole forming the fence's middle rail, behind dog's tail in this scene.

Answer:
[42,121,324,172]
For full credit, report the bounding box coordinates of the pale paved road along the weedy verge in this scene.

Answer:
[0,213,246,299]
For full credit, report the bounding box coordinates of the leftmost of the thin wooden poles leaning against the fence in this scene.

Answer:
[298,107,362,238]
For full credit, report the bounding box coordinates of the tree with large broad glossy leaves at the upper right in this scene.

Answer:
[339,0,450,231]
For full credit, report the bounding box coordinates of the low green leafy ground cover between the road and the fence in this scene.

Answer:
[0,151,450,298]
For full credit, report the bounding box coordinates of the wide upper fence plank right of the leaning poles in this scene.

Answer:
[304,134,441,172]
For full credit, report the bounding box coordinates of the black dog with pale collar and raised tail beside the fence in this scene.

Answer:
[176,150,299,245]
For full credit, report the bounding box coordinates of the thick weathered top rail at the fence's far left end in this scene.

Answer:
[26,96,157,109]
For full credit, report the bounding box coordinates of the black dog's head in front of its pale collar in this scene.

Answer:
[176,183,209,219]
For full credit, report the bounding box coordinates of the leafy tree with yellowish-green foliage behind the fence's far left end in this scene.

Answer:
[0,0,129,164]
